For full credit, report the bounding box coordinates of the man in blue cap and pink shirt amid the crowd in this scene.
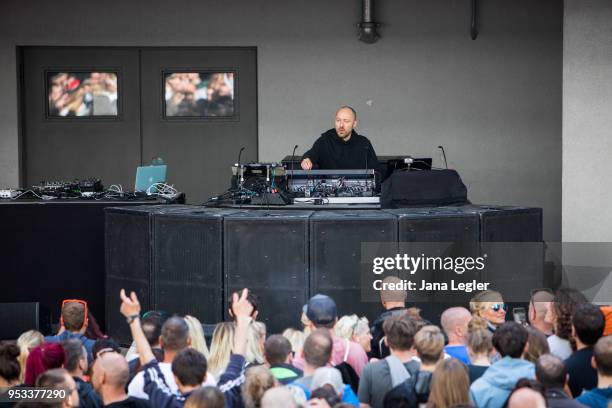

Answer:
[293,294,368,376]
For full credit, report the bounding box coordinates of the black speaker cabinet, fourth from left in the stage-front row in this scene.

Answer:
[310,210,397,321]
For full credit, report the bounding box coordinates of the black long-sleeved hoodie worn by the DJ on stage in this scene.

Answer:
[302,129,379,171]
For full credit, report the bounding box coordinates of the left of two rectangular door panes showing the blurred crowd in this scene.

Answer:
[47,71,118,117]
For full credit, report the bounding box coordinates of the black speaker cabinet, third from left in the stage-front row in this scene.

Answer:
[223,210,312,333]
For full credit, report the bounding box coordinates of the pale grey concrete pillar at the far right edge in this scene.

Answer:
[563,0,612,242]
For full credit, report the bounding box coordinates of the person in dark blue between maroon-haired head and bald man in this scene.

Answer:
[62,339,102,408]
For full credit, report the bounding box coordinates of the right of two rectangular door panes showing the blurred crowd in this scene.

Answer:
[164,72,235,118]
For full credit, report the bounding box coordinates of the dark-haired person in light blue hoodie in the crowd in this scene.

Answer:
[470,322,535,408]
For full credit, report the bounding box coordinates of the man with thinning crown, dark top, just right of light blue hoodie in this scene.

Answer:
[535,354,584,408]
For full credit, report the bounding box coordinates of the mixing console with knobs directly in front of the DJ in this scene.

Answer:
[286,169,376,198]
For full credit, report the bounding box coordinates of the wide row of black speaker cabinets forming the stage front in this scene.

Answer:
[105,205,545,343]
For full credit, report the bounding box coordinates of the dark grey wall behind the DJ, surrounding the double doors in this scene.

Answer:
[0,0,563,240]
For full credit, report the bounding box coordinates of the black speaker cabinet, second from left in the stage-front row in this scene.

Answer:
[152,207,238,323]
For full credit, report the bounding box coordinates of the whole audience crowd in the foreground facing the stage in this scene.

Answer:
[0,284,612,408]
